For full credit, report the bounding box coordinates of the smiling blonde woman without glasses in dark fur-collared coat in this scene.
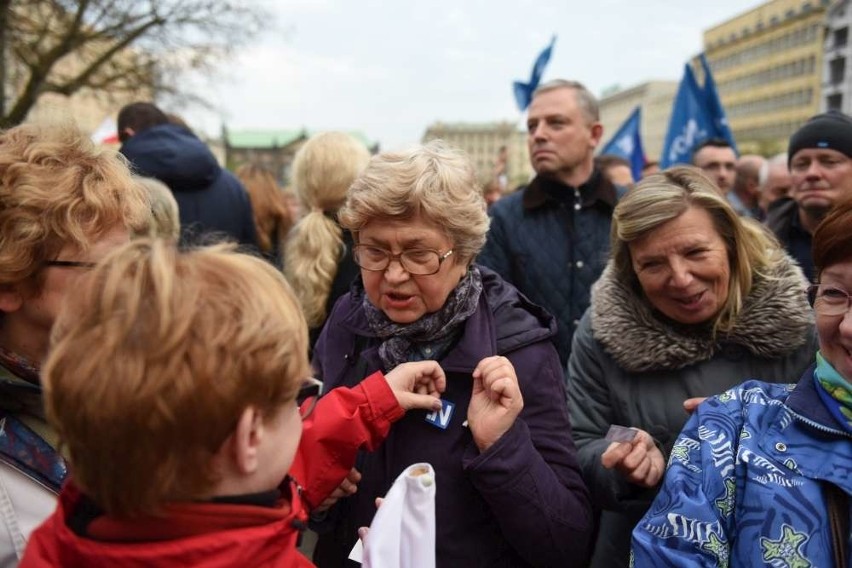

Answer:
[568,167,815,567]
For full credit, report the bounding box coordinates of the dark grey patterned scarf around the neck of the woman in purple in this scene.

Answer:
[364,266,482,370]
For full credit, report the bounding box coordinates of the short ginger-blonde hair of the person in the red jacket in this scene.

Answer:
[43,239,310,517]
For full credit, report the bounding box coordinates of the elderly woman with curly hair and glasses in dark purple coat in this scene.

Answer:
[314,142,591,566]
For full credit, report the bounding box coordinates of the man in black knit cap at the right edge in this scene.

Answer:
[766,111,852,282]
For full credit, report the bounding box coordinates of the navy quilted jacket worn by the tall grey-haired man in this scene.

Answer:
[477,170,619,366]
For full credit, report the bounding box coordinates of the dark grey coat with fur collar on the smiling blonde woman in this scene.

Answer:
[568,256,816,568]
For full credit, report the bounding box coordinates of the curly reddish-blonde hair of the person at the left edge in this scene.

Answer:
[0,123,151,293]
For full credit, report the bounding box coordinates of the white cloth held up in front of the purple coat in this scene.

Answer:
[364,463,437,568]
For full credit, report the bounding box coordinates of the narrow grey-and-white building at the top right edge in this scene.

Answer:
[820,0,852,115]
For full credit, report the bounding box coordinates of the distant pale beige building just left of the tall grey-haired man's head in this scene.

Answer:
[421,121,533,190]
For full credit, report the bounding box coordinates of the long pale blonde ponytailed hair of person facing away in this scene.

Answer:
[284,132,370,327]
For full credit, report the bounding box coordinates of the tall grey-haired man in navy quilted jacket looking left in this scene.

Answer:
[477,79,618,365]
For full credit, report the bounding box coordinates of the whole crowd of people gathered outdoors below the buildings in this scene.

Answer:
[0,80,852,568]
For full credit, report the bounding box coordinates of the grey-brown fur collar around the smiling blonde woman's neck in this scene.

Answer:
[591,254,813,372]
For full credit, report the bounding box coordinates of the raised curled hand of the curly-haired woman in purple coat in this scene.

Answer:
[467,356,524,452]
